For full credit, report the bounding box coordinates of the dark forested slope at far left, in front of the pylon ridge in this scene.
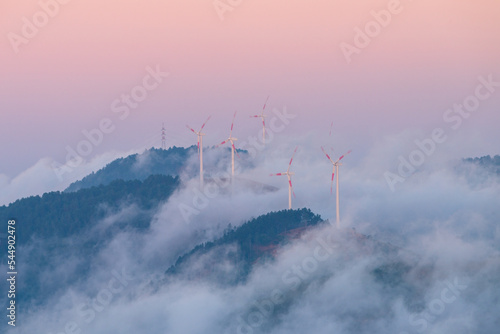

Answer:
[0,175,179,305]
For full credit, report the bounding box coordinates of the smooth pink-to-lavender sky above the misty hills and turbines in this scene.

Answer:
[0,0,500,194]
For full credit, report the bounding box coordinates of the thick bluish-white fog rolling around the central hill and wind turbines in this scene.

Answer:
[6,135,500,334]
